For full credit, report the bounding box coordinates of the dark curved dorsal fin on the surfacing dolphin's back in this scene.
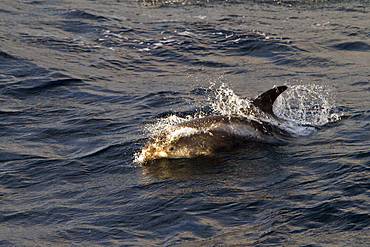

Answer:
[252,86,288,118]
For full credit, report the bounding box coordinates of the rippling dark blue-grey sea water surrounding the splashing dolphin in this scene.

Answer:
[0,0,370,246]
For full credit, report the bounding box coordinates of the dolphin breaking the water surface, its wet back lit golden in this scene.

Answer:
[136,86,291,164]
